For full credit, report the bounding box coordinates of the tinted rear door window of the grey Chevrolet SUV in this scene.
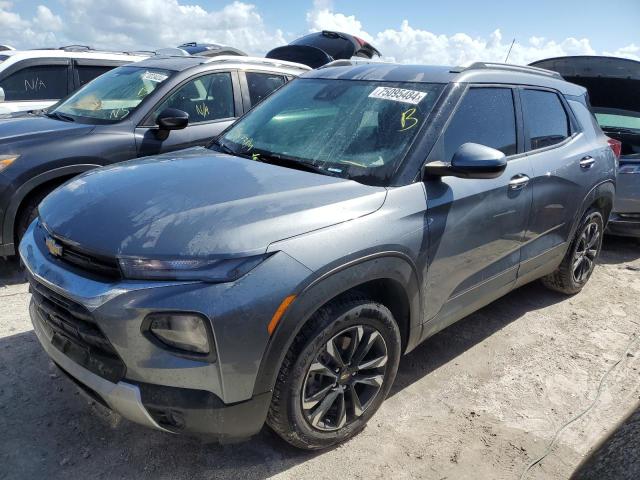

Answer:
[520,89,571,150]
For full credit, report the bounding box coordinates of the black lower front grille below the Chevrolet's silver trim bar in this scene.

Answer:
[29,277,126,383]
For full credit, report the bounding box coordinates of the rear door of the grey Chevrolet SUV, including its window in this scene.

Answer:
[519,87,602,266]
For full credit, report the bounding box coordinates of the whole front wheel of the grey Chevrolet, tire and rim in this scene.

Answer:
[267,295,401,450]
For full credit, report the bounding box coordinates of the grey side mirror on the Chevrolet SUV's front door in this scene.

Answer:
[423,143,507,179]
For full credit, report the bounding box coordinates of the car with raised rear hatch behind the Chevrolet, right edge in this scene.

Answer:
[531,56,640,238]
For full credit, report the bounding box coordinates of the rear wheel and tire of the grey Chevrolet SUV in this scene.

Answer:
[542,209,604,295]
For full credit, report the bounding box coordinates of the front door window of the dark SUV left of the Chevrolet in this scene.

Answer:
[153,72,235,125]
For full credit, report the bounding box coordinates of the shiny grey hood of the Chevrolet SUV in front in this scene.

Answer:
[39,147,386,257]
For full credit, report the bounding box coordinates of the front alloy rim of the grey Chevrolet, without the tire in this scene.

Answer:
[301,325,388,431]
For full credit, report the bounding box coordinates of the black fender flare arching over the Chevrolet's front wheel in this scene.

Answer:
[253,252,422,395]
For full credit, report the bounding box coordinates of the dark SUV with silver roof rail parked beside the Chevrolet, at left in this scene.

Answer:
[0,56,309,256]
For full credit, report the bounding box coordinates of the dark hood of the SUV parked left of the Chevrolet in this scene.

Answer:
[0,113,94,145]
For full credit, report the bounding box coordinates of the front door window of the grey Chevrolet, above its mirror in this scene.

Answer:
[443,88,517,162]
